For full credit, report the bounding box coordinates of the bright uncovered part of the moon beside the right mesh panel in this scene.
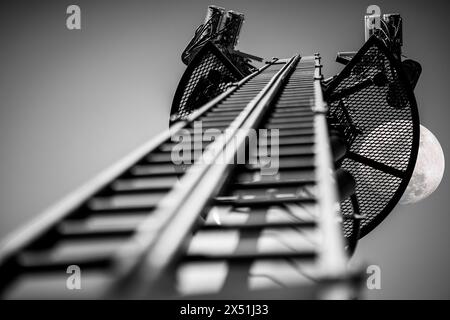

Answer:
[400,125,445,204]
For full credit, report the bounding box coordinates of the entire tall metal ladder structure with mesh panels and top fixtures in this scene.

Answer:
[0,6,420,299]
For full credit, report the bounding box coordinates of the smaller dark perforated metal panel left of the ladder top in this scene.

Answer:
[171,42,243,122]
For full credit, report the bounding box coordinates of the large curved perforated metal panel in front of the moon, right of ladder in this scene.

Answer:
[327,36,420,237]
